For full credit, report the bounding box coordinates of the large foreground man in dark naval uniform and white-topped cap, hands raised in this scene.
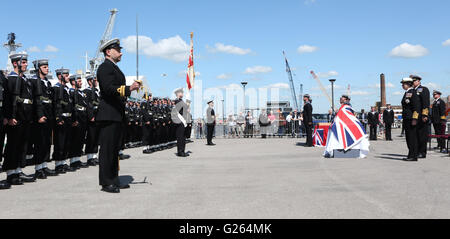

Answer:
[96,38,142,193]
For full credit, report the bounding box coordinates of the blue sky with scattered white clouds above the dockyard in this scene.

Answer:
[0,0,450,116]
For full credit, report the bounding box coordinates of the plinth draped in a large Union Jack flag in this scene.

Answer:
[324,105,370,158]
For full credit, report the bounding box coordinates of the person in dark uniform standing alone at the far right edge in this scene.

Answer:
[431,90,447,150]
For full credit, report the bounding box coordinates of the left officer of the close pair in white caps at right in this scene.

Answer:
[401,78,421,161]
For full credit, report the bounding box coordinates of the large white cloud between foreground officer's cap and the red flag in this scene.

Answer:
[122,35,189,62]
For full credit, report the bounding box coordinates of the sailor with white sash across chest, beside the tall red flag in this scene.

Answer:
[171,88,189,157]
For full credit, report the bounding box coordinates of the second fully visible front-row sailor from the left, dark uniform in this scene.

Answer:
[32,59,57,179]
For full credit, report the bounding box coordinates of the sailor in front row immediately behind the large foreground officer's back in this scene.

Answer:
[84,75,100,166]
